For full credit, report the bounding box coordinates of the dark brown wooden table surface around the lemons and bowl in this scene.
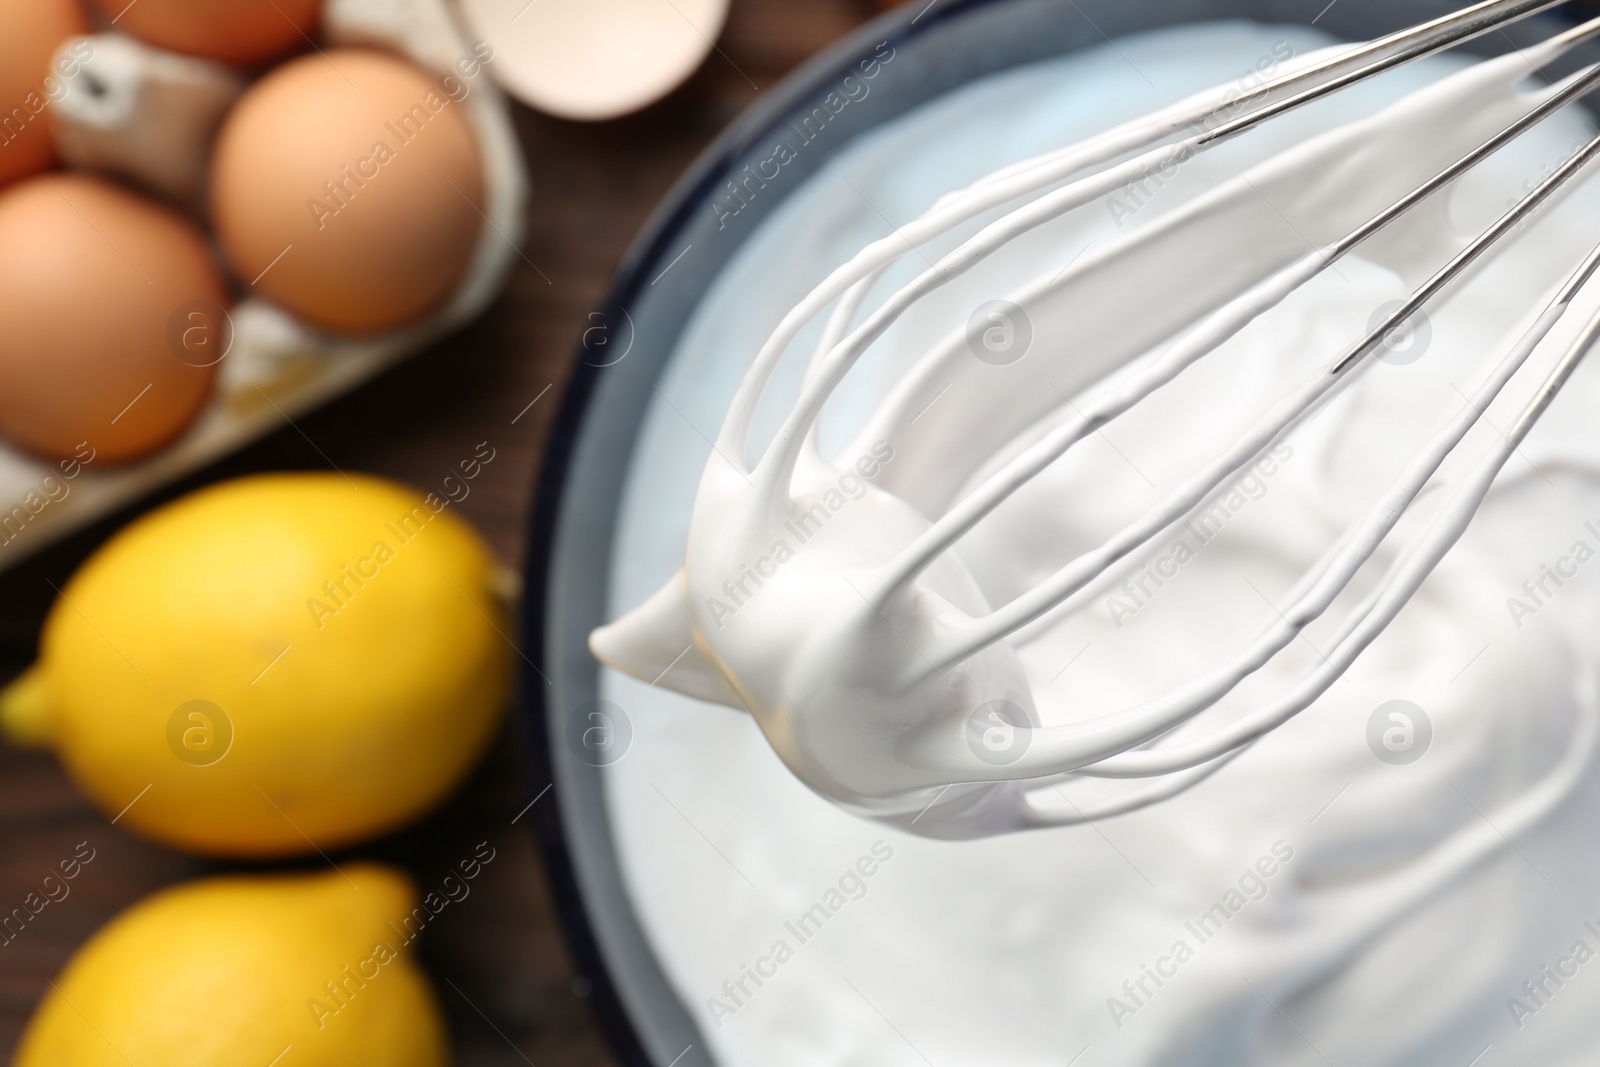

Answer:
[0,0,882,1067]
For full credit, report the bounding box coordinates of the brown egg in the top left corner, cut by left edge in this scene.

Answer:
[0,0,90,186]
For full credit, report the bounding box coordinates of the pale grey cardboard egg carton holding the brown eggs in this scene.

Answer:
[0,0,530,571]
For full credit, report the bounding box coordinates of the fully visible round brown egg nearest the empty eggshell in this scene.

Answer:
[211,50,483,333]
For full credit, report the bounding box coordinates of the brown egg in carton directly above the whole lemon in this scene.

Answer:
[0,173,227,464]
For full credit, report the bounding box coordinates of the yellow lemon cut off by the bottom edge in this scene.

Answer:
[13,864,450,1067]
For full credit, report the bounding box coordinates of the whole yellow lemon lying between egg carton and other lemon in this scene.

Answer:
[0,474,510,857]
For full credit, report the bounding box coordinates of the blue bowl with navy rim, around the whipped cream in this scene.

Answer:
[520,0,1600,1067]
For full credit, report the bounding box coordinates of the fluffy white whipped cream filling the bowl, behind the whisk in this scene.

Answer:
[592,24,1600,1065]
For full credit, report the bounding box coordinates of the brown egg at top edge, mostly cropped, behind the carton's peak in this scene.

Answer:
[94,0,322,66]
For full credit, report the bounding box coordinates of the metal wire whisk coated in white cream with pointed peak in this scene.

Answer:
[590,0,1600,838]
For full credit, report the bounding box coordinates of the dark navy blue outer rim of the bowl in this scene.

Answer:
[518,0,1600,1067]
